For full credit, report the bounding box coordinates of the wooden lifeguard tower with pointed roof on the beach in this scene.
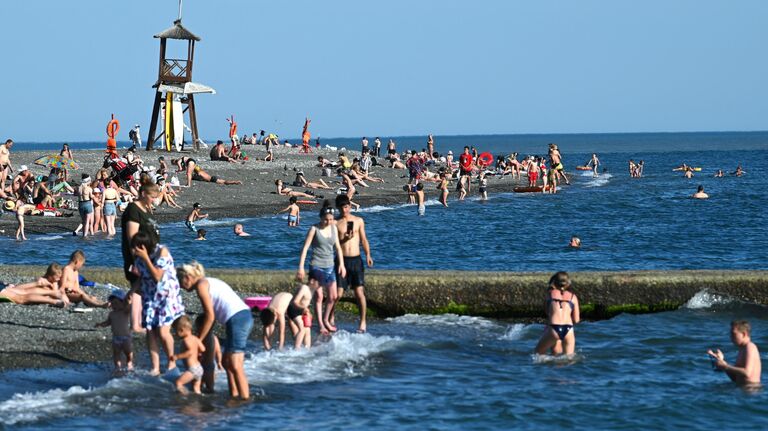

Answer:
[147,12,216,151]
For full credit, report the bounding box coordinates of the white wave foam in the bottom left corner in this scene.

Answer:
[0,376,169,425]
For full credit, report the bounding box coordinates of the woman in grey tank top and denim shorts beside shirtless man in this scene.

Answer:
[296,200,347,335]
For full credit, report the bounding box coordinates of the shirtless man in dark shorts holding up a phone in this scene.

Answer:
[329,195,373,333]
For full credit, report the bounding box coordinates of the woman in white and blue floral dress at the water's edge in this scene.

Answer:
[131,232,184,374]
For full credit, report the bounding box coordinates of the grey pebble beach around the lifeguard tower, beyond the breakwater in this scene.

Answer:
[0,145,522,236]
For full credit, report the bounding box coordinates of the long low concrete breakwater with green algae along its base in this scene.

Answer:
[3,266,768,319]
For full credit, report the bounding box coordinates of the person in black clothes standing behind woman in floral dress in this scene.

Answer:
[120,183,160,333]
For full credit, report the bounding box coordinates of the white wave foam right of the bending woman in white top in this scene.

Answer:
[245,331,404,384]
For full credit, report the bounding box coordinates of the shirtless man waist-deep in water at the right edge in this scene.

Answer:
[707,320,762,385]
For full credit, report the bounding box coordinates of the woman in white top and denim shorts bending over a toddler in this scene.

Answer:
[176,262,253,400]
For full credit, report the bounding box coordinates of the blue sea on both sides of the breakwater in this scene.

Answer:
[0,132,768,430]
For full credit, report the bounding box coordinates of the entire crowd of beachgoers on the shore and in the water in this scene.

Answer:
[0,132,760,399]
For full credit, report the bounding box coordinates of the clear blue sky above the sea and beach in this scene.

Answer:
[0,0,768,141]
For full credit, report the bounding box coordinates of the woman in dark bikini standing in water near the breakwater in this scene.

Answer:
[536,271,581,355]
